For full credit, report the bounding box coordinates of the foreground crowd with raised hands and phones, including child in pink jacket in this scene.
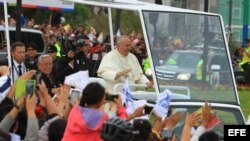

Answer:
[0,67,219,141]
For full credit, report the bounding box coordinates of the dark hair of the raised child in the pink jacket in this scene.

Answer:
[80,82,105,107]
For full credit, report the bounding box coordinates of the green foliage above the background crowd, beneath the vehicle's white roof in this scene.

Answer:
[64,4,142,34]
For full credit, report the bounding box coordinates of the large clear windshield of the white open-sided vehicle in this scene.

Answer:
[143,11,237,103]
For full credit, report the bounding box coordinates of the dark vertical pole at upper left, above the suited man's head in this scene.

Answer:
[16,0,22,41]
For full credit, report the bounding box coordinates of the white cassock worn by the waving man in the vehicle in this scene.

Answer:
[97,49,149,94]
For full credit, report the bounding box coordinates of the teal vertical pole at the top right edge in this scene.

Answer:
[242,0,249,46]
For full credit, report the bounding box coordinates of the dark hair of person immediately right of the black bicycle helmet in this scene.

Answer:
[133,119,152,141]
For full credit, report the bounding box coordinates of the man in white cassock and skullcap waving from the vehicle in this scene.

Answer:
[97,36,153,94]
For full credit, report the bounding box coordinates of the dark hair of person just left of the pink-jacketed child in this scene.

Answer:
[48,119,67,141]
